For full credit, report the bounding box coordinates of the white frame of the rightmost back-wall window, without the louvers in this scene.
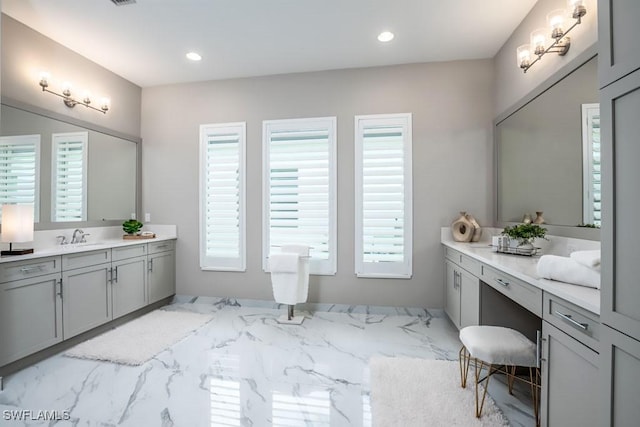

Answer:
[354,113,413,279]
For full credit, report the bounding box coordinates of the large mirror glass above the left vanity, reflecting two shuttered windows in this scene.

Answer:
[0,99,139,229]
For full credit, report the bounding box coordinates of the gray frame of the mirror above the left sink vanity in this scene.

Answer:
[0,96,142,231]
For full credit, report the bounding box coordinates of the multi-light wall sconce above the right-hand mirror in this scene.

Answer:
[516,0,587,73]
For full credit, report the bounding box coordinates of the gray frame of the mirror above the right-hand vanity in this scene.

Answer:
[493,43,600,240]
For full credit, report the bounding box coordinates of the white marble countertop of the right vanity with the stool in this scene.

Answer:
[441,237,600,315]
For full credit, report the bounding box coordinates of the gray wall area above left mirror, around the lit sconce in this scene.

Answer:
[0,14,141,137]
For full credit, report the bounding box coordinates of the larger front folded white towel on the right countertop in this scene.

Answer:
[537,255,600,289]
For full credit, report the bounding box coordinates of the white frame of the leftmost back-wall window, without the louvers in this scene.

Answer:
[198,122,247,272]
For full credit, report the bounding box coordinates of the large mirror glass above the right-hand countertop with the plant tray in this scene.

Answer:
[495,56,600,231]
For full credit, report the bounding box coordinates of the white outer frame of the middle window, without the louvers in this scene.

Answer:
[262,116,338,276]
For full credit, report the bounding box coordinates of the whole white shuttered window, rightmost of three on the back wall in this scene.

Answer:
[355,114,412,278]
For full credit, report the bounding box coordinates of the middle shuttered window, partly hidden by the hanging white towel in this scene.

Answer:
[262,117,337,275]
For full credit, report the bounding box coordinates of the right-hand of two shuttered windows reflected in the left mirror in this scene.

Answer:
[51,132,89,222]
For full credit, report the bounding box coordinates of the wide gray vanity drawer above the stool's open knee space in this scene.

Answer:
[482,265,542,317]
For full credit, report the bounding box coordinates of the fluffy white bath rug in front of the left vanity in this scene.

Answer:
[65,310,213,365]
